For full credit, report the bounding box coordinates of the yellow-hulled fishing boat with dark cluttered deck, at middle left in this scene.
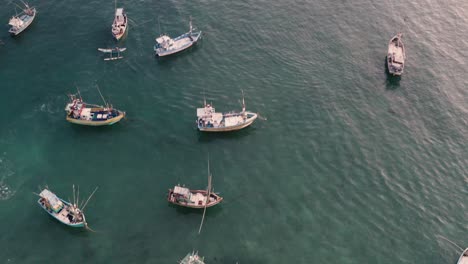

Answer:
[65,88,125,126]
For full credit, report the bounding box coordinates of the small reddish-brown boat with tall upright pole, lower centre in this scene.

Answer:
[167,159,223,209]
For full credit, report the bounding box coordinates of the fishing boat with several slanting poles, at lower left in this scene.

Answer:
[37,186,97,228]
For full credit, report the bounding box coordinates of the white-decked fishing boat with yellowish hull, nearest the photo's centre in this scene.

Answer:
[197,92,258,132]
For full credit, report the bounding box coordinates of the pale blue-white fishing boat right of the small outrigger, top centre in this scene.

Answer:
[154,19,201,57]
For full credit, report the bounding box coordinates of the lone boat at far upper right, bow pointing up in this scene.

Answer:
[387,33,406,75]
